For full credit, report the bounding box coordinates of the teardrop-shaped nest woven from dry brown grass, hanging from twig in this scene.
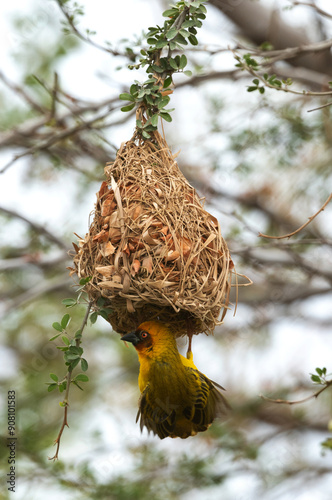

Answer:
[74,132,234,335]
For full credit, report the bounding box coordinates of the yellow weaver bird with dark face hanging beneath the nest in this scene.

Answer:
[121,321,229,439]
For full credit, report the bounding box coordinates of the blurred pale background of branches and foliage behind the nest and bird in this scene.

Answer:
[0,0,332,500]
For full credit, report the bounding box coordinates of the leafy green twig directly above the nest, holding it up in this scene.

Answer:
[120,0,206,139]
